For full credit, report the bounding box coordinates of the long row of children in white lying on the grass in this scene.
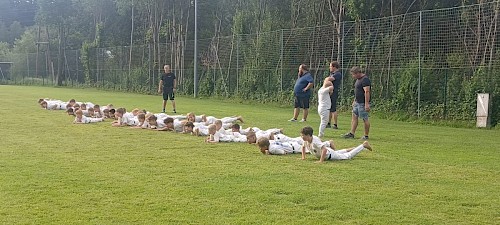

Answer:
[39,99,372,162]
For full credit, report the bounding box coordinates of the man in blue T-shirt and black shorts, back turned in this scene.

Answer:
[289,64,314,122]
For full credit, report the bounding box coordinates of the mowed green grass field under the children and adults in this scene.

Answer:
[0,86,500,224]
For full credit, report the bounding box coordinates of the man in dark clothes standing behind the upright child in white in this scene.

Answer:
[326,61,342,129]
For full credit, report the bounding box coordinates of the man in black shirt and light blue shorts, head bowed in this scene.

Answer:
[343,66,372,140]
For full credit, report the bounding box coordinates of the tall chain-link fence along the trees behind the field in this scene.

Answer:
[3,2,500,123]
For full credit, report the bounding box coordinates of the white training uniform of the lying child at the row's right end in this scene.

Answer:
[302,136,364,160]
